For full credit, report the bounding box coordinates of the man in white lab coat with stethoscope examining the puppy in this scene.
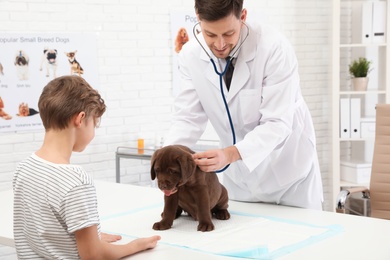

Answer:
[164,0,323,210]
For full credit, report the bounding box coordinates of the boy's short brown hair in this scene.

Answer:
[38,76,106,130]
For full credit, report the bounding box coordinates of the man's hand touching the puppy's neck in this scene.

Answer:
[192,146,241,172]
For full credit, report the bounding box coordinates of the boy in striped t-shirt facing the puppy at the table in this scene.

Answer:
[13,76,160,260]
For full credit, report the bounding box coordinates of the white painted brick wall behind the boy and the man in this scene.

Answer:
[0,0,333,210]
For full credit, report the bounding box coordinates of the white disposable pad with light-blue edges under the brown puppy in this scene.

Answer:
[101,205,341,259]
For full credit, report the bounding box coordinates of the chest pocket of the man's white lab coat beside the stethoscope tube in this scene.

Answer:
[239,89,261,125]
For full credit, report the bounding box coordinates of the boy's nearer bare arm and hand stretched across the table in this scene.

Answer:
[75,225,160,260]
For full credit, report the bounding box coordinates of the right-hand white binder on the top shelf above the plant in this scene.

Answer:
[372,1,386,43]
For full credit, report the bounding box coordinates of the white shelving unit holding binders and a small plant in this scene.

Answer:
[331,0,390,211]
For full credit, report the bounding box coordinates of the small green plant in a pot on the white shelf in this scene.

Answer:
[349,57,371,91]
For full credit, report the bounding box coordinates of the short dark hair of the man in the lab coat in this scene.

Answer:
[195,0,244,22]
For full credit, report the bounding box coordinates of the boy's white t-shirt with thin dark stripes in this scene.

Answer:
[13,154,100,259]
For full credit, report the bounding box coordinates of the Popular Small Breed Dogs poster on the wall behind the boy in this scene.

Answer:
[0,33,99,132]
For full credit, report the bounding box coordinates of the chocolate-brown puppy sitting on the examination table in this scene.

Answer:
[150,145,230,231]
